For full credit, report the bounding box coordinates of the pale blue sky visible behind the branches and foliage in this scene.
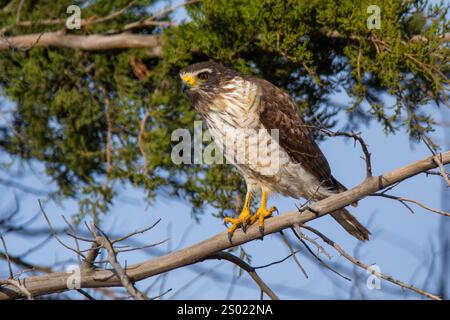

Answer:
[0,0,450,299]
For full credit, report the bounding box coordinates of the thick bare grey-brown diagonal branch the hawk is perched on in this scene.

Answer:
[0,151,450,299]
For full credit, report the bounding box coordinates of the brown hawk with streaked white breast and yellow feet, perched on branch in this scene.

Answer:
[180,61,370,241]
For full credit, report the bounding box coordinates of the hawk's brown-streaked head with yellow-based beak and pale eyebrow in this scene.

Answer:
[180,61,237,110]
